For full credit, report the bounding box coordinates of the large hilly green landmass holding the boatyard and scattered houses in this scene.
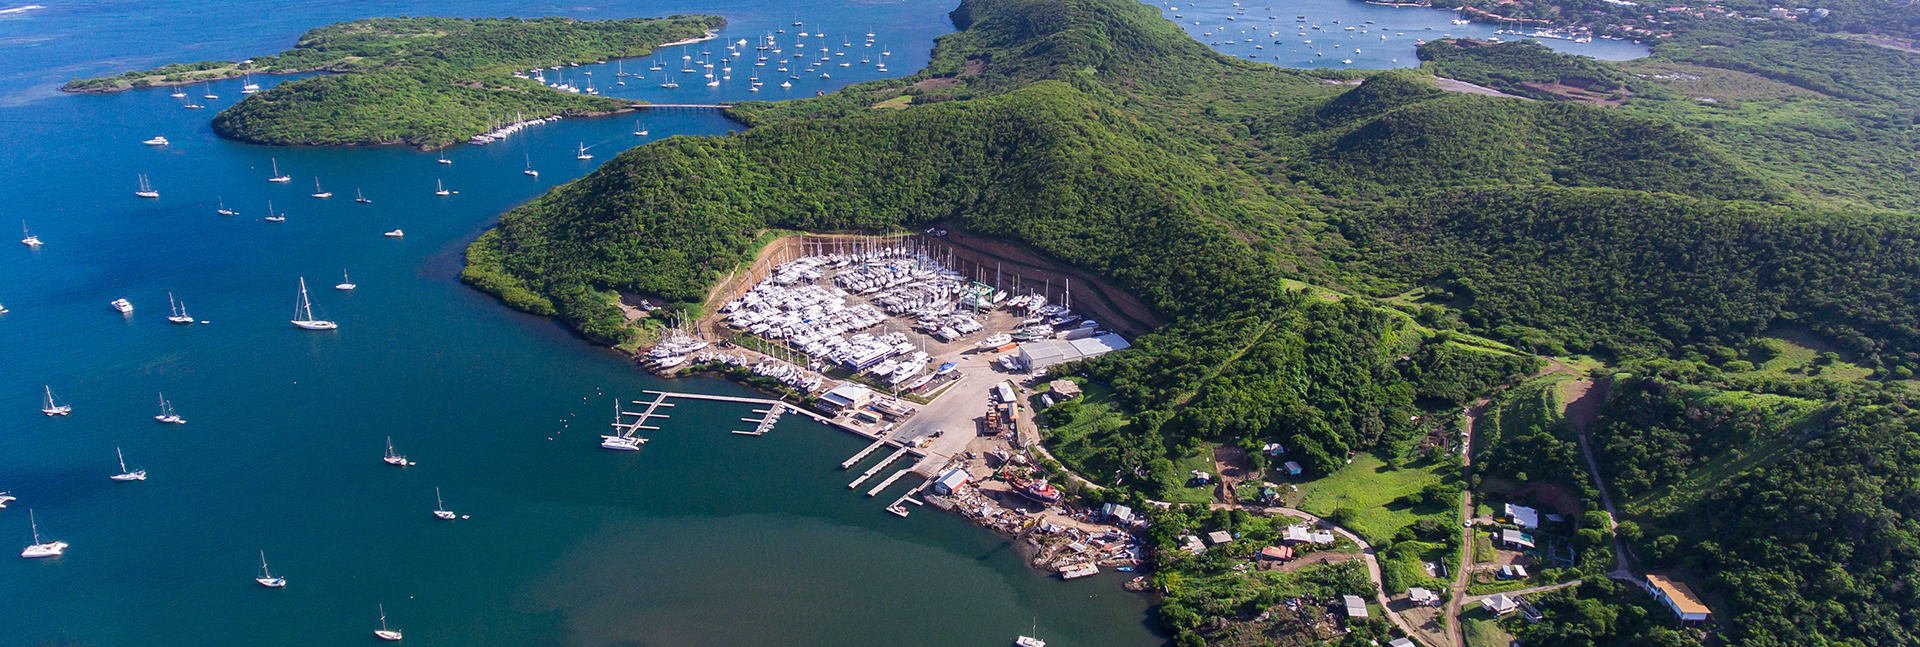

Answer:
[463,0,1920,647]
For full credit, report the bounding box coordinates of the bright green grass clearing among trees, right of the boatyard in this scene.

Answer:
[1288,453,1457,541]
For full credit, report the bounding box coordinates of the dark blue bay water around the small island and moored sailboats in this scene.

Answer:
[0,0,1160,647]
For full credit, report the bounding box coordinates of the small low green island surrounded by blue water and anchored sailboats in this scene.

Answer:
[63,15,726,150]
